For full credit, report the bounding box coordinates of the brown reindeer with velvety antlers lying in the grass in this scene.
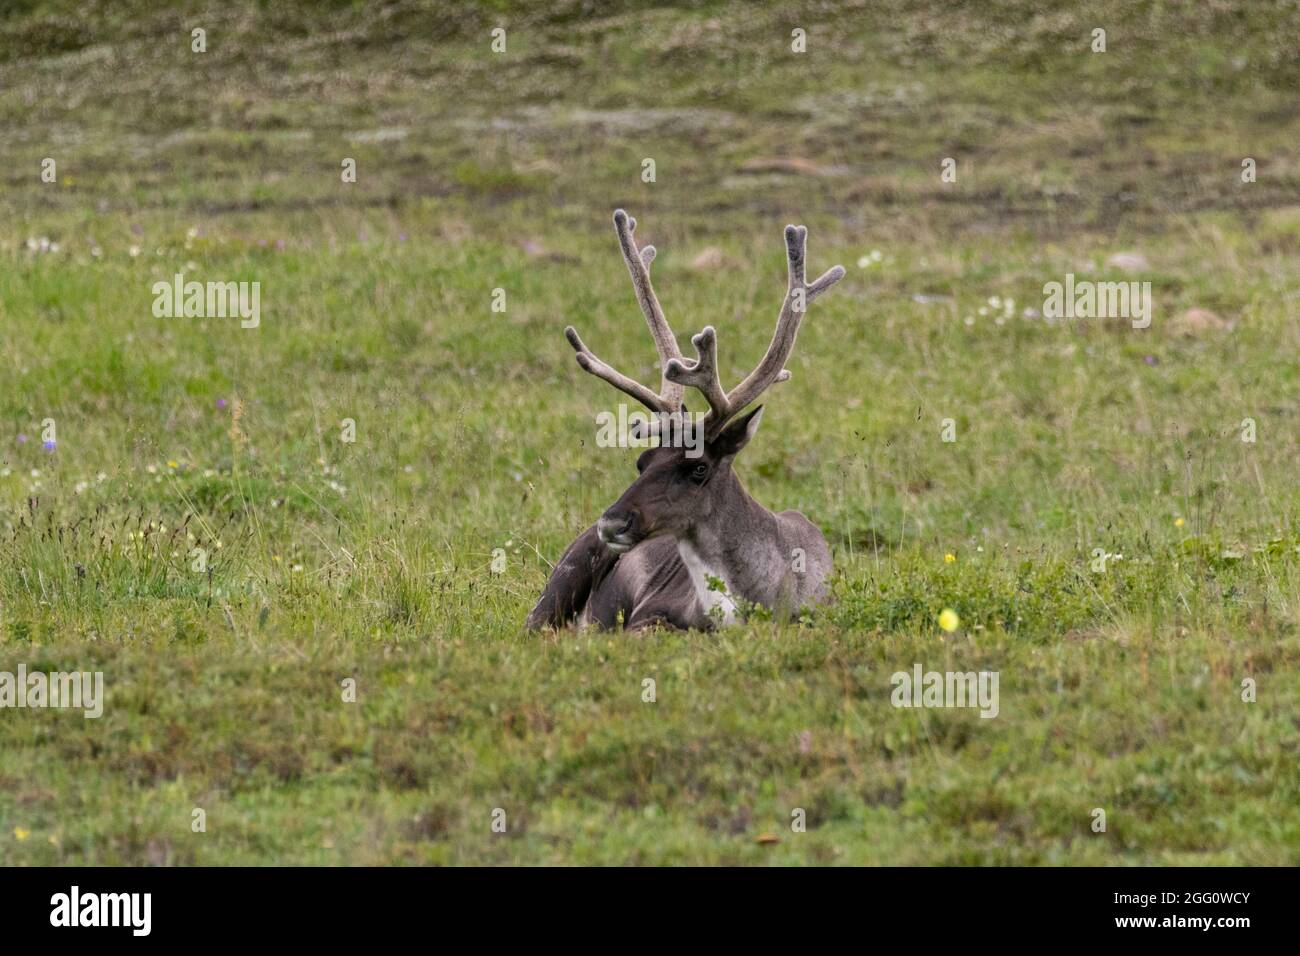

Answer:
[528,209,844,628]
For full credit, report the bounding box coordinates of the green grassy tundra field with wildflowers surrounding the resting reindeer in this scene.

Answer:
[0,0,1300,865]
